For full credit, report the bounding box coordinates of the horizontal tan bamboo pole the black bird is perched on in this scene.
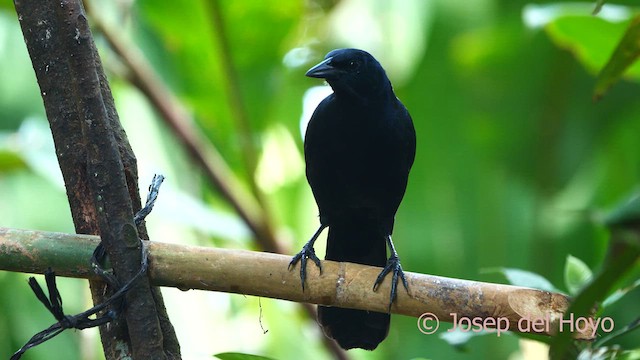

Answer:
[0,228,594,340]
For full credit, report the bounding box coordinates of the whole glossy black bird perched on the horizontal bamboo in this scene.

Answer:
[289,49,416,350]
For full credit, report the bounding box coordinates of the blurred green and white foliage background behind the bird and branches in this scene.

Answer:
[0,0,640,359]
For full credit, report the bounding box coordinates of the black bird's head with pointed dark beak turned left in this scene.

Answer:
[306,49,391,99]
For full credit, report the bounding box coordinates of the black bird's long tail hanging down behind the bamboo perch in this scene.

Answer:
[318,215,390,350]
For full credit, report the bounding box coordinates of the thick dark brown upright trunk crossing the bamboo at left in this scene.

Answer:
[15,0,180,359]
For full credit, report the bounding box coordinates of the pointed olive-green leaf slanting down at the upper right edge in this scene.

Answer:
[593,15,640,99]
